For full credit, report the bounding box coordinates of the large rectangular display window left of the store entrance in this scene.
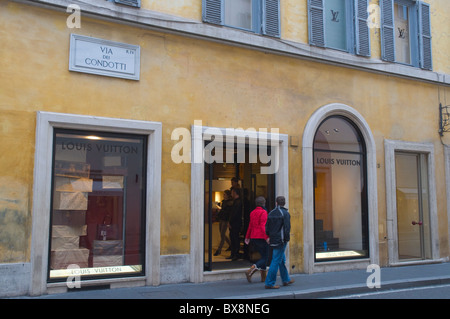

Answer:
[48,129,147,281]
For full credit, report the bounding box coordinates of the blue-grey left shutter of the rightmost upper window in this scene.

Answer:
[380,0,395,62]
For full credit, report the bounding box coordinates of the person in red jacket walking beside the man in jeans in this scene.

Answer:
[244,196,269,282]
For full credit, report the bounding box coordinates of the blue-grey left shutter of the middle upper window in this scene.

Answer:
[308,0,325,47]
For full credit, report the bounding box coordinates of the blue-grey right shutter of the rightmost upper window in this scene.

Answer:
[419,2,433,70]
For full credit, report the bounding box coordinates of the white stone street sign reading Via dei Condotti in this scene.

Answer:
[69,34,140,80]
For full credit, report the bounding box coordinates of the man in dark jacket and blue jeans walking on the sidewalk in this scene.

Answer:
[265,196,294,289]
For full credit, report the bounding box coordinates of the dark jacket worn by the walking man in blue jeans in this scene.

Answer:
[266,206,291,246]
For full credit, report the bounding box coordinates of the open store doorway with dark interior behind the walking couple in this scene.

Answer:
[204,145,275,271]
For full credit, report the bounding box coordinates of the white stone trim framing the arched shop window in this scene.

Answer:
[302,103,379,273]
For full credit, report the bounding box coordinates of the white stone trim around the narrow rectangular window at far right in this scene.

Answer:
[384,140,440,265]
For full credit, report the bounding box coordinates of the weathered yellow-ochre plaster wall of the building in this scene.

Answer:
[0,0,450,296]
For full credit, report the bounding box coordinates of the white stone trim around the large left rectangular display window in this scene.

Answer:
[30,112,162,295]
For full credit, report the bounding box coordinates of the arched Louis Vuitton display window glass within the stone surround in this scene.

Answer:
[313,116,369,262]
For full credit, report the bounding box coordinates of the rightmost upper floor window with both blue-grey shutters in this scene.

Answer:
[380,0,432,70]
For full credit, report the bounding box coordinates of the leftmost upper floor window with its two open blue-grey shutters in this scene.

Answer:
[203,0,280,37]
